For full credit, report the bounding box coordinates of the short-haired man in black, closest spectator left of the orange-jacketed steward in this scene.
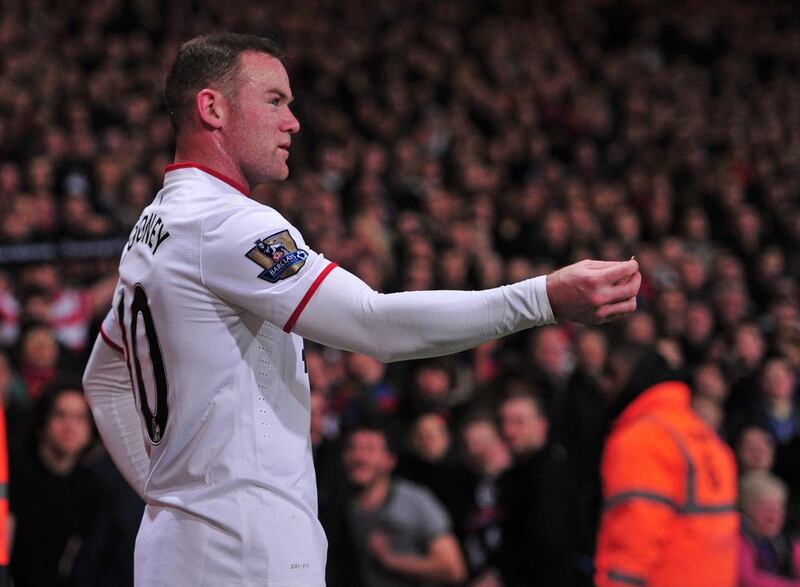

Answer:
[499,395,576,587]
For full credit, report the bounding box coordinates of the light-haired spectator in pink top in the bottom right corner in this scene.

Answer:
[739,471,800,587]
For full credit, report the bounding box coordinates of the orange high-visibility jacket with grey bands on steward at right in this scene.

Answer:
[595,382,739,587]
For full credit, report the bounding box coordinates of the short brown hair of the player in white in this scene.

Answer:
[164,33,283,133]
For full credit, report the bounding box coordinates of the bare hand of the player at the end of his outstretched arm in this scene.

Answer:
[547,259,642,324]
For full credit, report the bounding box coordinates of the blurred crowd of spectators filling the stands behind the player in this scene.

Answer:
[0,0,800,586]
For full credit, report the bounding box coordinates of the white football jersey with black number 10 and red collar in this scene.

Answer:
[102,163,335,587]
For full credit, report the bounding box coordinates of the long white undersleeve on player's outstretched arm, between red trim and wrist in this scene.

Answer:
[294,267,555,362]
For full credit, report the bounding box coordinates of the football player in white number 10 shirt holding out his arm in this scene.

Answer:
[85,34,641,587]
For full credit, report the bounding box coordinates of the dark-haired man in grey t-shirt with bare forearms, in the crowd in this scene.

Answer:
[344,428,466,587]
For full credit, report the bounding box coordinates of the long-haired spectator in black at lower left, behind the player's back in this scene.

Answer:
[10,386,99,587]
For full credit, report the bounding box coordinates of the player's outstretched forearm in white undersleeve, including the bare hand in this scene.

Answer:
[294,261,641,362]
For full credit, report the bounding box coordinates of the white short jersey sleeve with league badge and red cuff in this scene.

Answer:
[200,208,336,332]
